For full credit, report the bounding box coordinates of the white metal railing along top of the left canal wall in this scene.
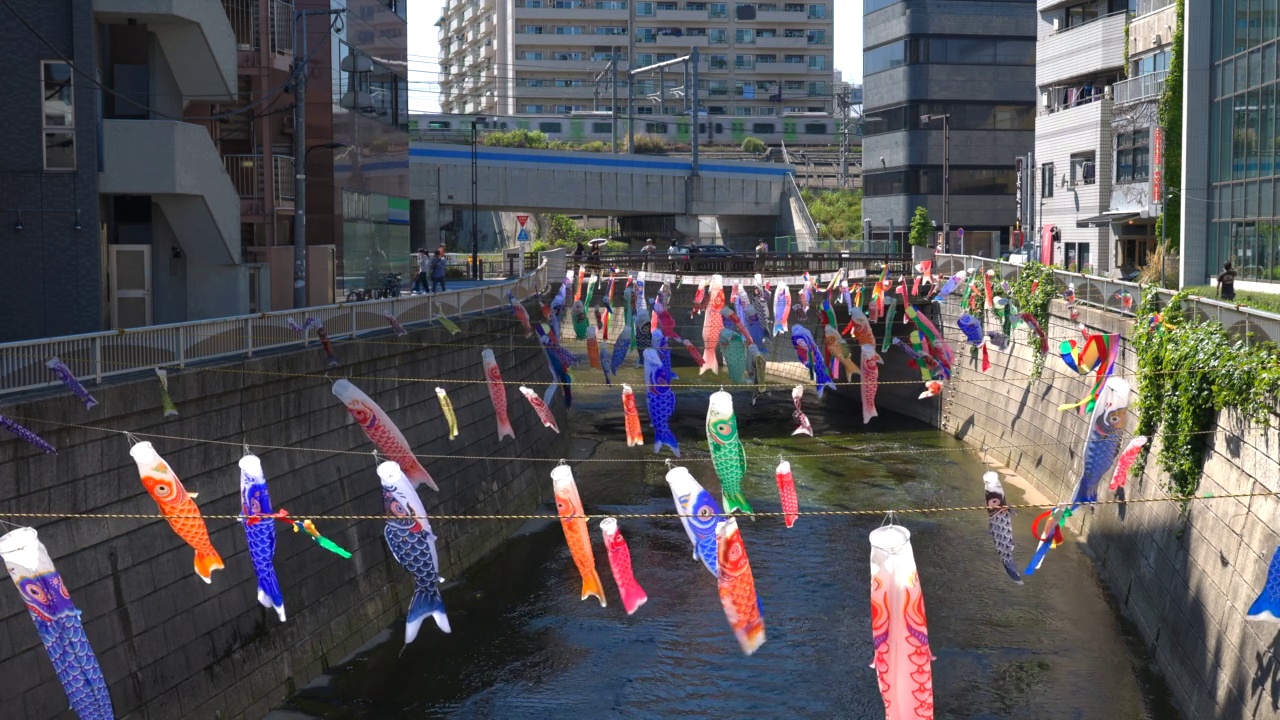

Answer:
[0,250,550,396]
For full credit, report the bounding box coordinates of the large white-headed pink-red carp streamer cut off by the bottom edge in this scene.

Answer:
[870,525,933,720]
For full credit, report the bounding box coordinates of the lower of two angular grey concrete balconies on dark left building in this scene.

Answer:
[97,120,241,265]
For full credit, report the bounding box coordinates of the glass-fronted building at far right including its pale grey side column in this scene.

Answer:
[1170,3,1280,285]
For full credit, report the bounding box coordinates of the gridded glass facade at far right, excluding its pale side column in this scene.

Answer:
[1208,0,1280,283]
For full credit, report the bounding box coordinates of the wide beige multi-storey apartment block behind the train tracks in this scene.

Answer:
[436,0,836,118]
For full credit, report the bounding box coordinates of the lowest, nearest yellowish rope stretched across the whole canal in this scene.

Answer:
[0,492,1280,521]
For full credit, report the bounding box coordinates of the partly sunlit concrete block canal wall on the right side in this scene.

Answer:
[921,293,1280,720]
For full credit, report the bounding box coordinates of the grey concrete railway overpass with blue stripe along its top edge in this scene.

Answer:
[410,142,815,245]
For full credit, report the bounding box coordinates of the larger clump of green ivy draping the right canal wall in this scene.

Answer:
[1132,284,1280,496]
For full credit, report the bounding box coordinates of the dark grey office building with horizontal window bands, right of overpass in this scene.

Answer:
[863,0,1043,256]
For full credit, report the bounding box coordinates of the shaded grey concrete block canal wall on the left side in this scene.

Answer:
[0,310,567,720]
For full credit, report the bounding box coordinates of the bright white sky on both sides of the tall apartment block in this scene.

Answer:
[408,0,863,113]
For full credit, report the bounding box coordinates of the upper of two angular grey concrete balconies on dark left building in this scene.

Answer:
[93,0,238,104]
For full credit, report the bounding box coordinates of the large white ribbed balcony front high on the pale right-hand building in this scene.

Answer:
[1036,12,1129,87]
